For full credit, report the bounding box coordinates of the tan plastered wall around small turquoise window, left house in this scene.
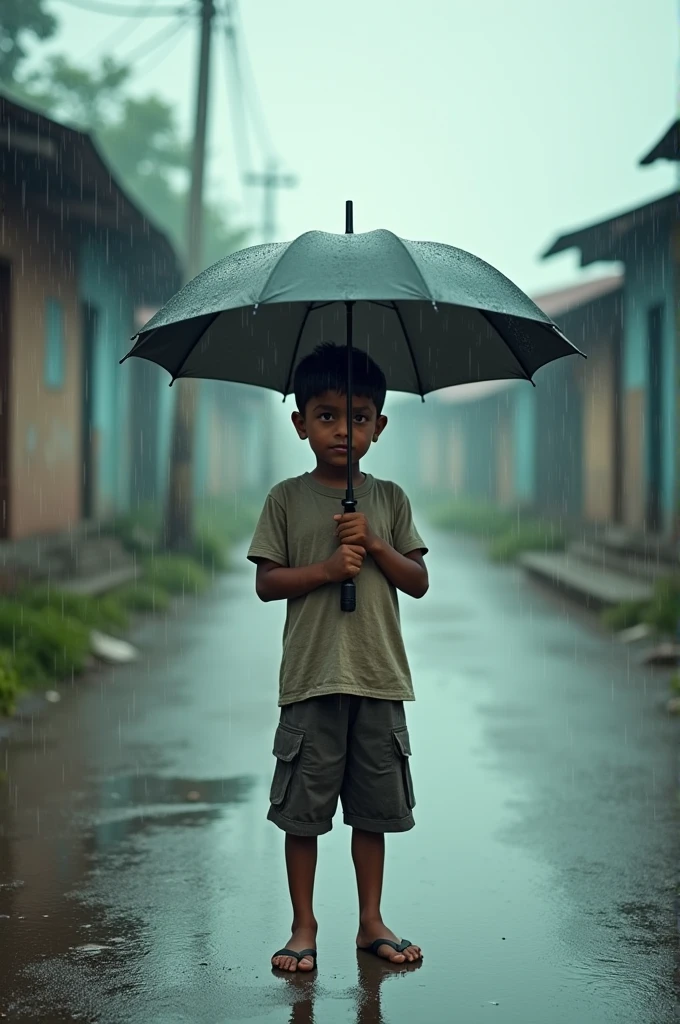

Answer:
[0,194,81,538]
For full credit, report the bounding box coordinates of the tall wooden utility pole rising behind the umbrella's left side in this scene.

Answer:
[166,0,215,551]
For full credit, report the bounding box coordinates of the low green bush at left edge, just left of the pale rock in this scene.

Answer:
[0,600,90,679]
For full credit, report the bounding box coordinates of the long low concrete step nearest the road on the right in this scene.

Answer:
[519,551,653,610]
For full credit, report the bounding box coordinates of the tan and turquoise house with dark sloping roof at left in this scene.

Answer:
[0,96,180,539]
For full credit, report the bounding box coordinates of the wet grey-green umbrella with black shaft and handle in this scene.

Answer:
[121,202,583,611]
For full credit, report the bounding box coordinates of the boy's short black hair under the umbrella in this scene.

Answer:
[293,342,387,416]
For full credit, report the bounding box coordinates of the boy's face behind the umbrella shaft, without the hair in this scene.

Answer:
[291,391,387,468]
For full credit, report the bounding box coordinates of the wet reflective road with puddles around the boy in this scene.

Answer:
[0,530,680,1024]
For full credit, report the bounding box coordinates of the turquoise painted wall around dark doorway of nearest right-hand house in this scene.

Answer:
[623,225,677,531]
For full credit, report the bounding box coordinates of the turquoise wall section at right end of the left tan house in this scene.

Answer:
[79,240,134,517]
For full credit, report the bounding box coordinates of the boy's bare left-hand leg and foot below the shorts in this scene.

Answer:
[271,833,317,971]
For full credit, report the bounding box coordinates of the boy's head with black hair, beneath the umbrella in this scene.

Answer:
[292,343,387,466]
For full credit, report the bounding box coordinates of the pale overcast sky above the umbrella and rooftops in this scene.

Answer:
[49,0,678,294]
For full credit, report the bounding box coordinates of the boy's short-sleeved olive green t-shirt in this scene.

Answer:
[248,473,427,707]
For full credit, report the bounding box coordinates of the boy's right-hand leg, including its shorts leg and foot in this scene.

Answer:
[341,697,422,964]
